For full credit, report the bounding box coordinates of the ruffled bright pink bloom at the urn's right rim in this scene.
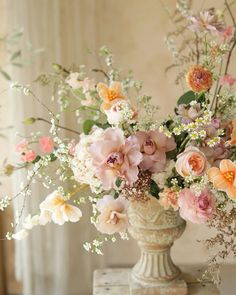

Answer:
[178,188,215,224]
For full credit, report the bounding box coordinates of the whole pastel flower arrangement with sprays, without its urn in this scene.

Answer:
[0,1,236,286]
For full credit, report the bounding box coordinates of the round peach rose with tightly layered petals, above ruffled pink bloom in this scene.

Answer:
[175,146,208,177]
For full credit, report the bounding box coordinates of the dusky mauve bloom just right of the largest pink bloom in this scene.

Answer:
[133,131,176,172]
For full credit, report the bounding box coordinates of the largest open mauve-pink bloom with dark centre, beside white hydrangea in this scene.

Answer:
[90,128,143,189]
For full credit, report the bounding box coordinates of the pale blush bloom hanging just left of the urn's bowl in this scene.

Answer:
[96,195,129,235]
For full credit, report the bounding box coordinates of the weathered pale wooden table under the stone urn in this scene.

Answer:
[93,267,220,295]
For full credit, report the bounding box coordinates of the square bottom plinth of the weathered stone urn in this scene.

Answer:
[130,279,188,295]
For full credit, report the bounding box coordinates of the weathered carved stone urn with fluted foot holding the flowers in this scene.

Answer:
[128,197,187,295]
